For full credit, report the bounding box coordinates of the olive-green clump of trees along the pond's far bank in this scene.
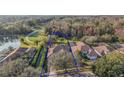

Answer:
[0,22,32,35]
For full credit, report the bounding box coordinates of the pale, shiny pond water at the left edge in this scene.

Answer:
[0,36,20,60]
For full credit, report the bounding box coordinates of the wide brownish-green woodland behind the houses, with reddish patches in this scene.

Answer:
[46,16,124,42]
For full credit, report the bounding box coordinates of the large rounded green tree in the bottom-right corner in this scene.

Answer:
[93,52,124,77]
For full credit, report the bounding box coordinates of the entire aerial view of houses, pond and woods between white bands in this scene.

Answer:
[0,16,124,77]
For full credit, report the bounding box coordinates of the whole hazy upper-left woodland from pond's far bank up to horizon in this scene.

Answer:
[0,16,53,35]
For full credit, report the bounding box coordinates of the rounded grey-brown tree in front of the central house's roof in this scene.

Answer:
[48,51,73,71]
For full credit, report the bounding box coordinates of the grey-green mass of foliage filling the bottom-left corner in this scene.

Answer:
[0,60,41,77]
